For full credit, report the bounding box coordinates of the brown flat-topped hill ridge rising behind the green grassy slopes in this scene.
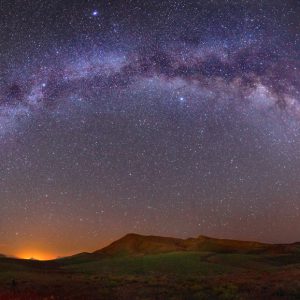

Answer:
[93,233,299,255]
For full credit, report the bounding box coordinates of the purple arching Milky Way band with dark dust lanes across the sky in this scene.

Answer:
[0,37,300,136]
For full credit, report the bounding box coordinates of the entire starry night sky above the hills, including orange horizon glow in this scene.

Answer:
[0,0,300,257]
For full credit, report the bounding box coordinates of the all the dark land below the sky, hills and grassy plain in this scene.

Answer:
[0,234,300,299]
